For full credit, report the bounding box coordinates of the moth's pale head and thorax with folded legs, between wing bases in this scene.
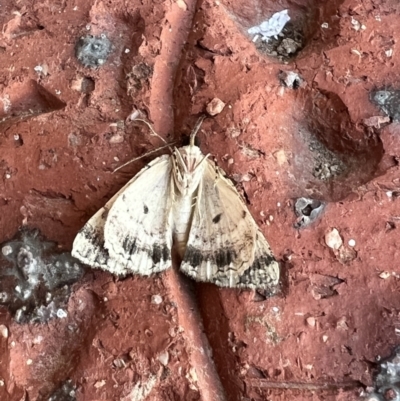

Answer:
[172,145,208,195]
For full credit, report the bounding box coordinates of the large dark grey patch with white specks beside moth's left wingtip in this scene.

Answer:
[0,231,84,323]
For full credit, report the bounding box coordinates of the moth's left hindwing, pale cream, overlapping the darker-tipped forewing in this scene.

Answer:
[104,156,172,275]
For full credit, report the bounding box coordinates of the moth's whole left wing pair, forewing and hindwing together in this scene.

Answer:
[72,155,172,275]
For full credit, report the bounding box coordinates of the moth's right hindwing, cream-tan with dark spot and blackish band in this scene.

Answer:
[181,162,255,286]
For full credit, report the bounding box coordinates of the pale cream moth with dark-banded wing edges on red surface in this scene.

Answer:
[72,120,279,293]
